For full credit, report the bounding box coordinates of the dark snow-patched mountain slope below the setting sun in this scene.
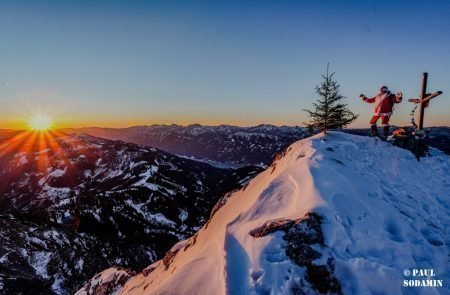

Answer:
[0,132,260,294]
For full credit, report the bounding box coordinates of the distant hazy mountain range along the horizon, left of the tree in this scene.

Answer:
[60,124,307,165]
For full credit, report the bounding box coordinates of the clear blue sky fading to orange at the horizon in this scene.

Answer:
[0,0,450,128]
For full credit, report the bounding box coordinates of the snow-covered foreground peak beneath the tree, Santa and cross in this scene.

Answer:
[77,132,450,295]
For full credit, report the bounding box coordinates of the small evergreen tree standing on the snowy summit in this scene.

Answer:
[303,64,358,132]
